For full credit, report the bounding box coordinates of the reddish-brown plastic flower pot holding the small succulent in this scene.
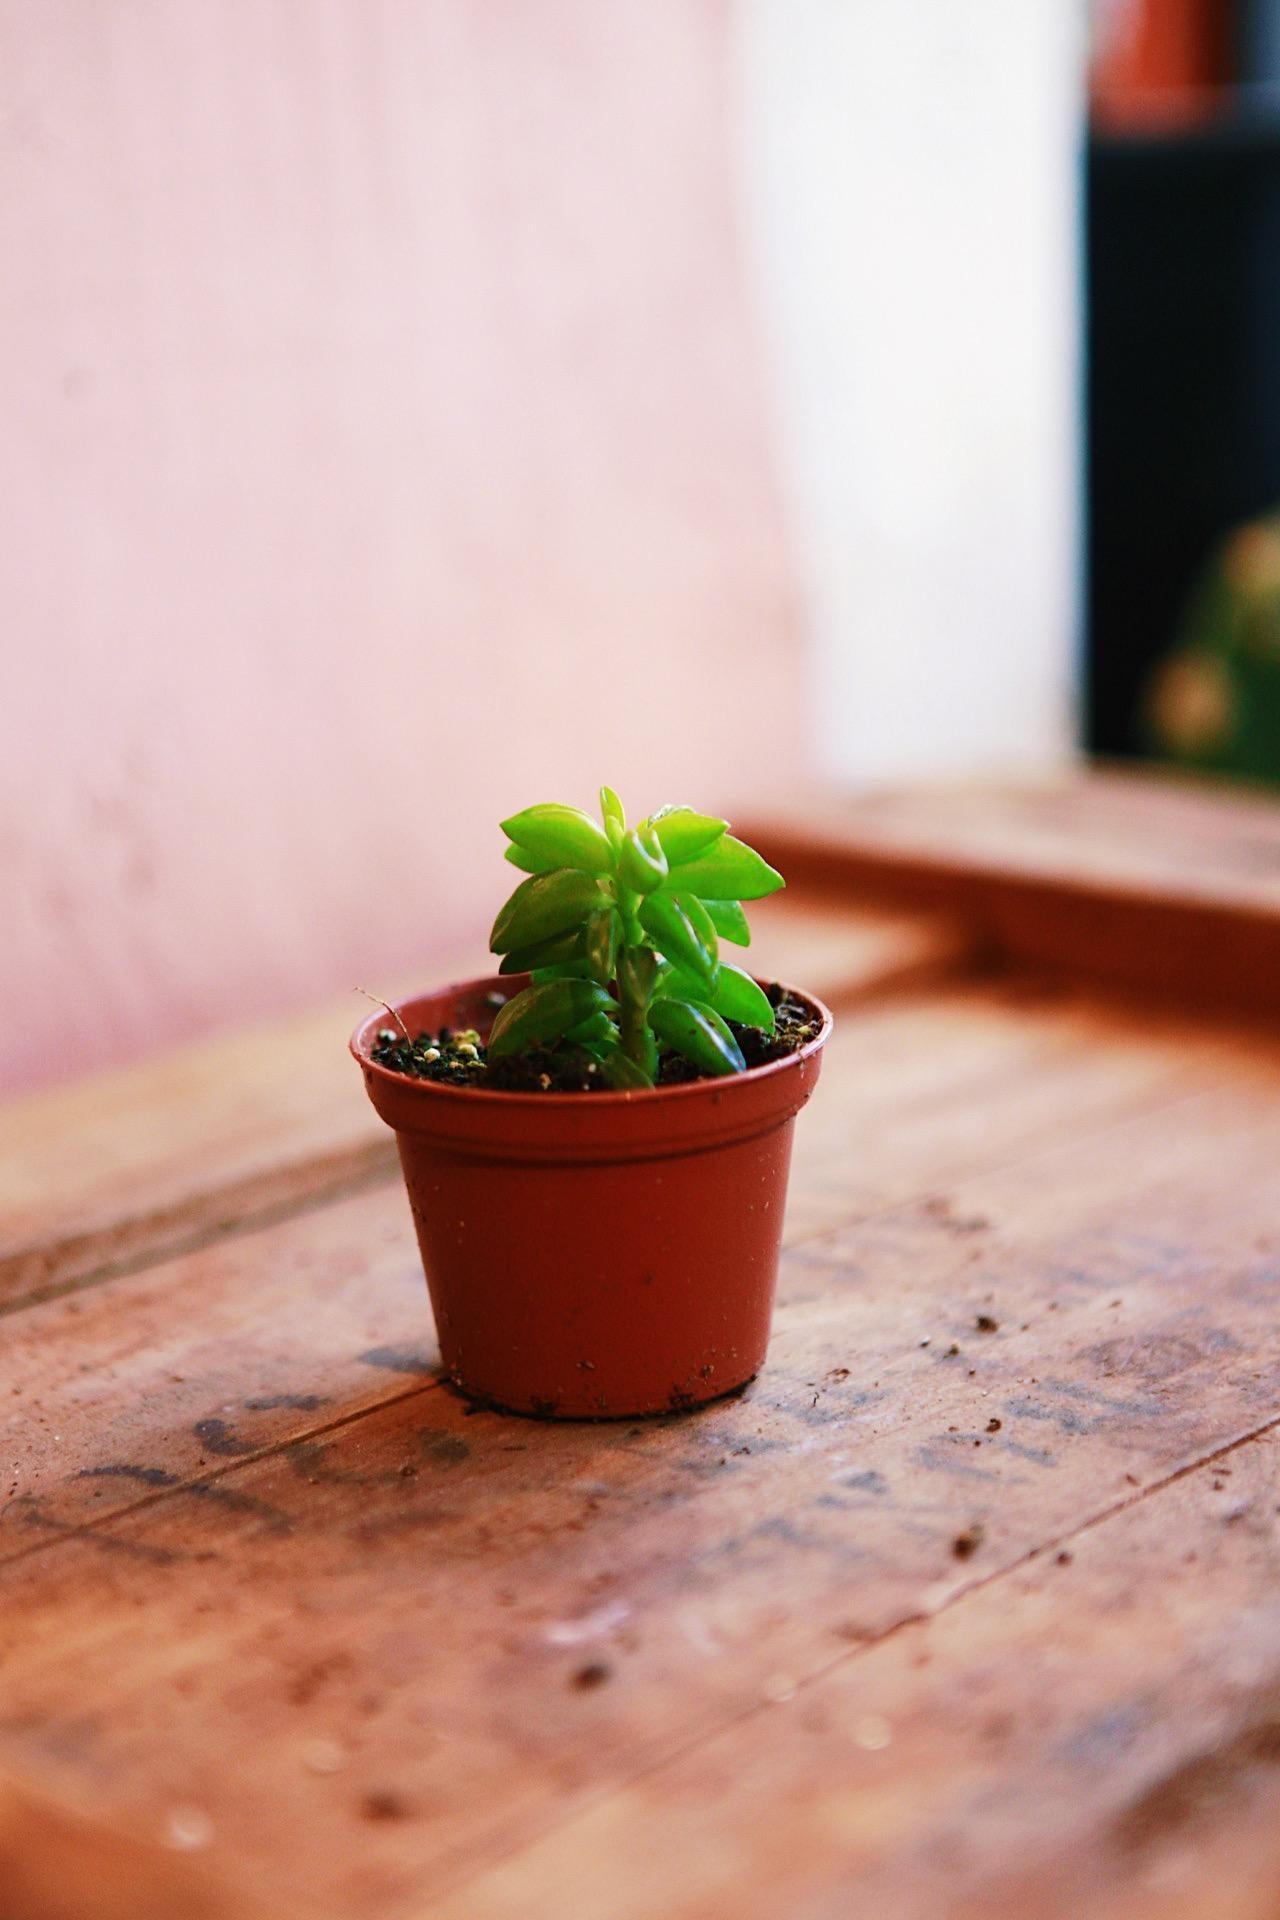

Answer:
[351,975,831,1419]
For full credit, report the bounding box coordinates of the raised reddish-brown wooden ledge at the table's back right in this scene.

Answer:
[750,770,1280,1018]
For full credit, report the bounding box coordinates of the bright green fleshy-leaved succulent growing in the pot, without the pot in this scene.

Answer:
[489,787,785,1089]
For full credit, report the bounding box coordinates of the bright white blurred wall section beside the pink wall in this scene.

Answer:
[739,0,1084,780]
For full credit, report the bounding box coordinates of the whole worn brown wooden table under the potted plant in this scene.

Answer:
[0,780,1280,1920]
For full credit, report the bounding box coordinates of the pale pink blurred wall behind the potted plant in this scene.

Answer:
[0,0,804,1089]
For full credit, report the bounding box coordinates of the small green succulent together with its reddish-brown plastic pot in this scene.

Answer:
[351,787,831,1419]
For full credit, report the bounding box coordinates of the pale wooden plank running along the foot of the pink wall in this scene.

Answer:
[0,893,960,1308]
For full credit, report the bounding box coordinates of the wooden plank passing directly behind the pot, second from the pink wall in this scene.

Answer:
[0,989,1238,1559]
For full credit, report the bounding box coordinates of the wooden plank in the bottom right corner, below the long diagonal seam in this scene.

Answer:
[427,1430,1280,1920]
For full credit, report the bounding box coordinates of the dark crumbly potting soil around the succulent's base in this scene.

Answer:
[372,985,819,1092]
